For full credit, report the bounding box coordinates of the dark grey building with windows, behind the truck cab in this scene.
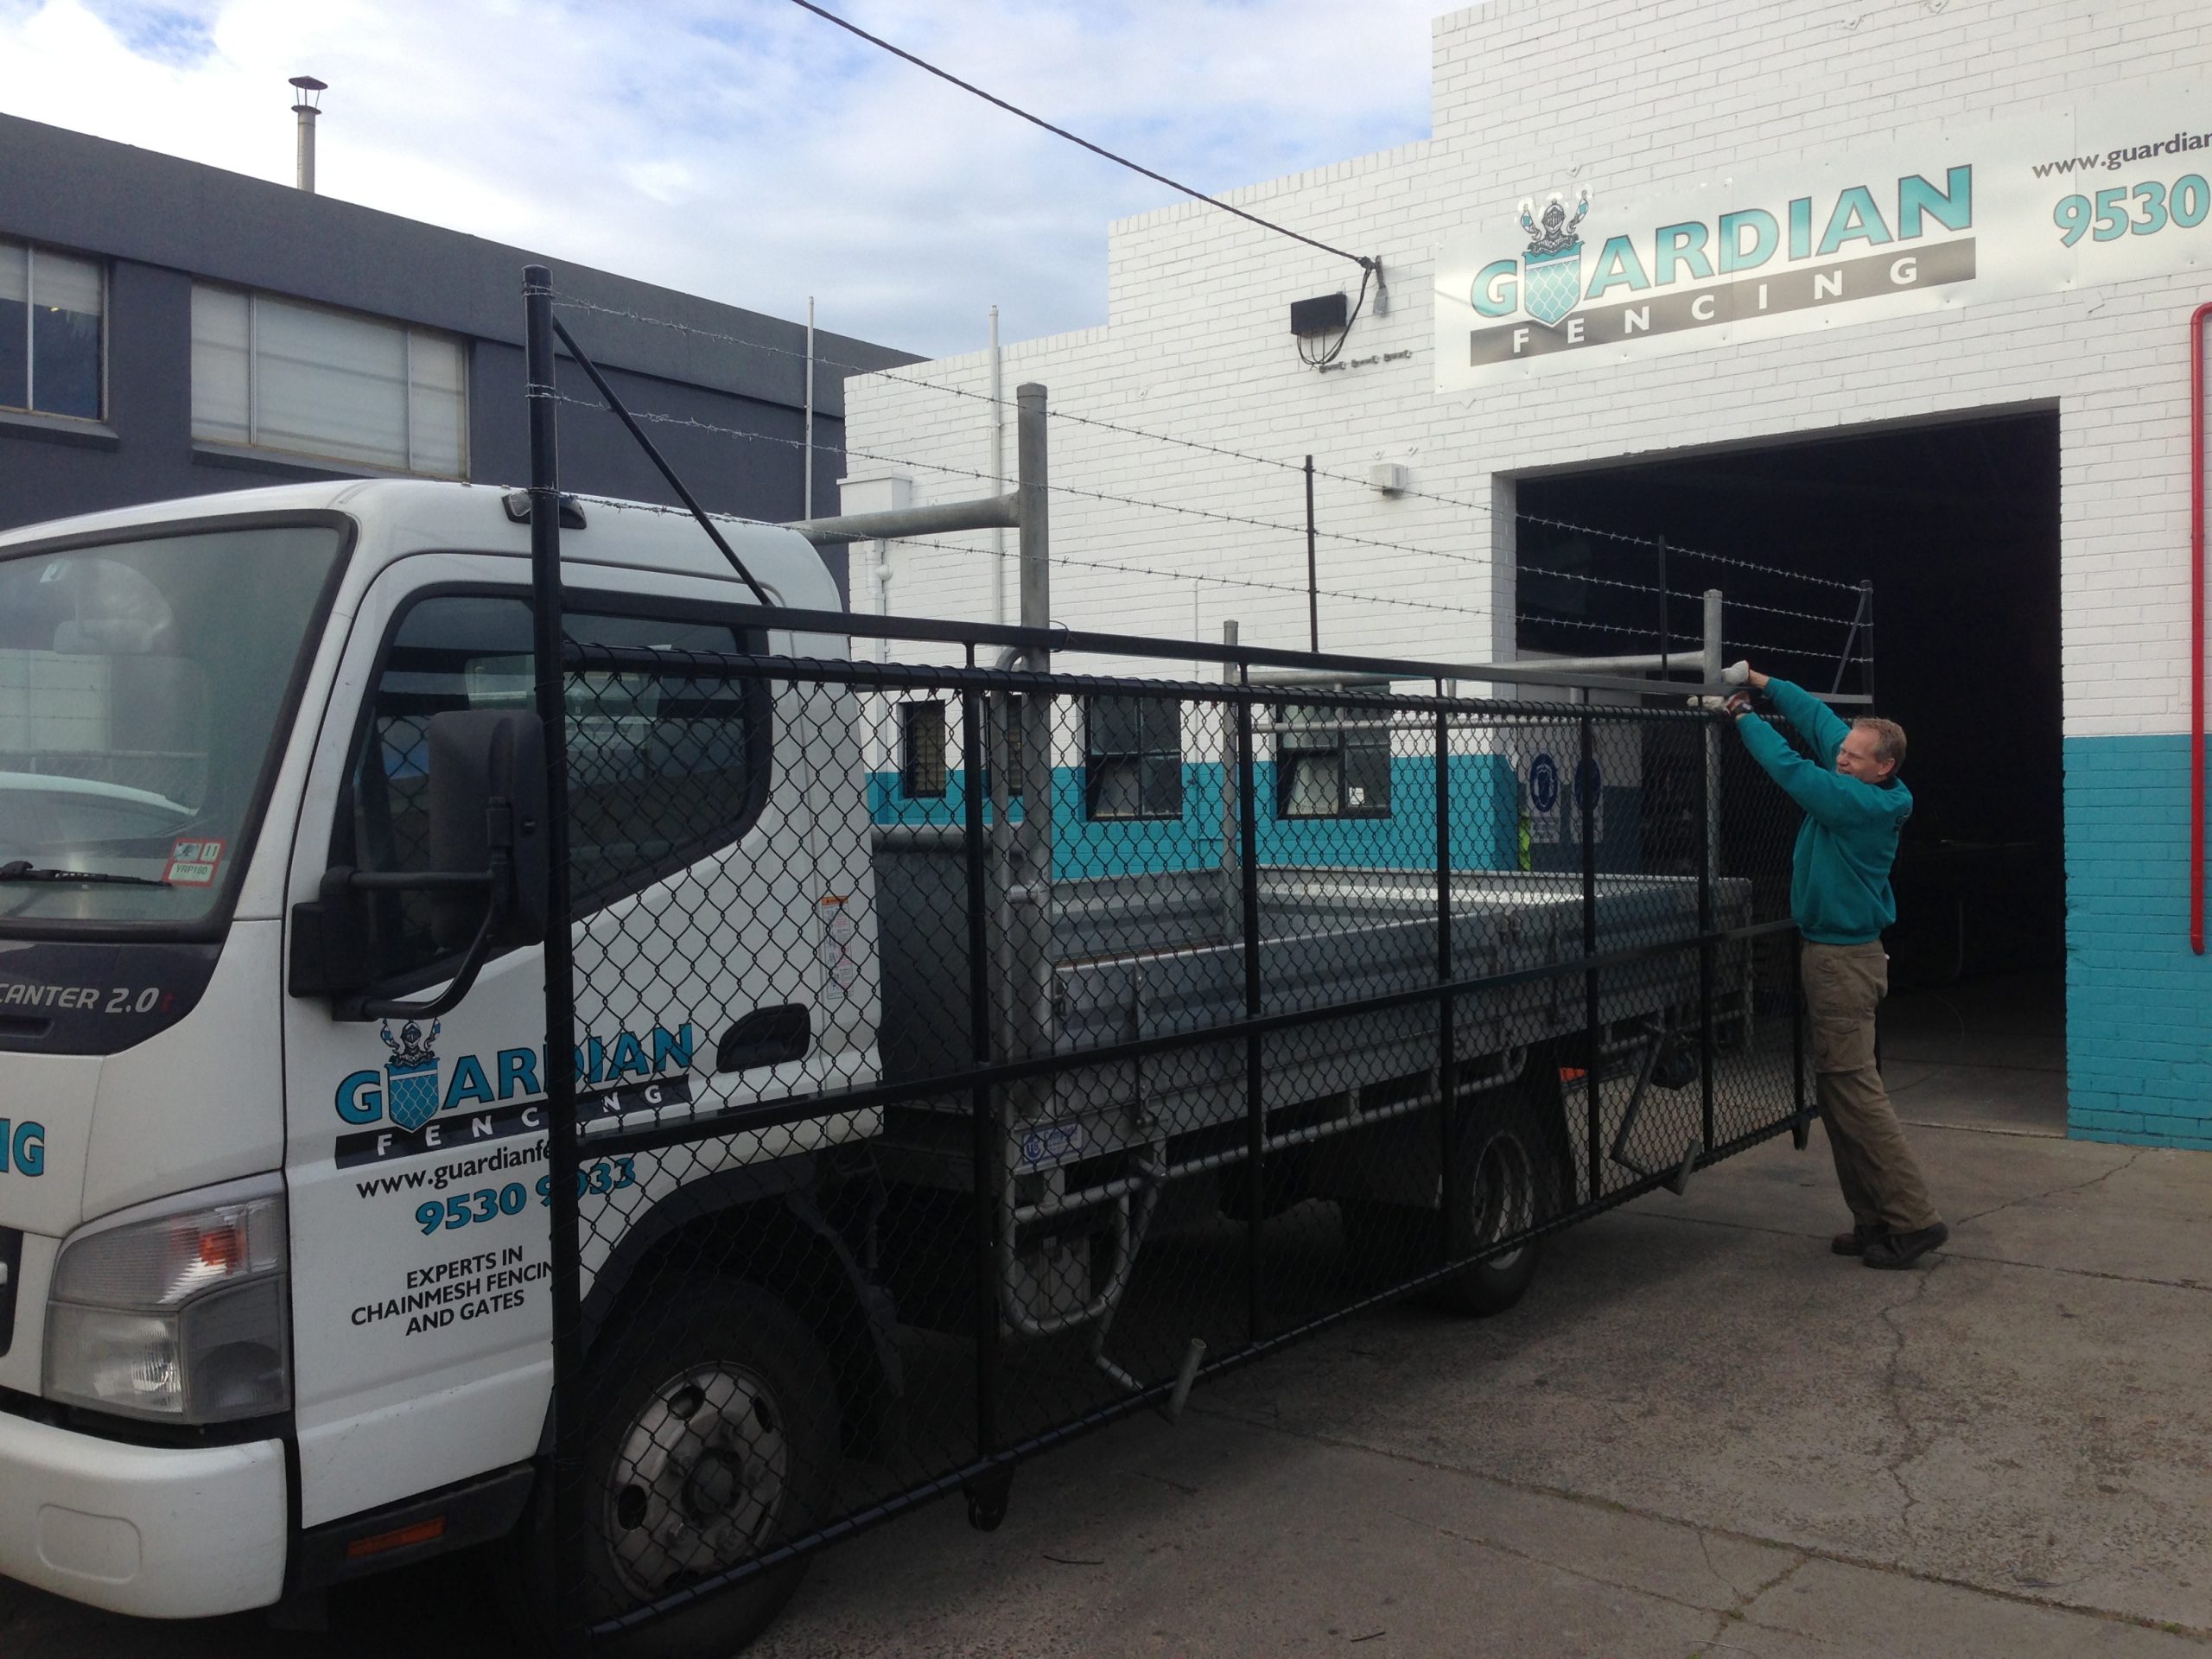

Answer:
[0,115,912,593]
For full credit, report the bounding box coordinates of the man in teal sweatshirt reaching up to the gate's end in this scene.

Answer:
[1727,668,1951,1268]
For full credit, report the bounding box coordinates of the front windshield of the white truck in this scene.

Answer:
[0,524,340,931]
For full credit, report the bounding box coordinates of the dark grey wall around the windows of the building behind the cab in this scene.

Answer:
[0,115,918,606]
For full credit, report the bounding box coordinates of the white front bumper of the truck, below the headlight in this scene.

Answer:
[0,1414,285,1619]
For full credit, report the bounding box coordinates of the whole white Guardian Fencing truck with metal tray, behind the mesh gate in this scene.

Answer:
[0,482,1750,1639]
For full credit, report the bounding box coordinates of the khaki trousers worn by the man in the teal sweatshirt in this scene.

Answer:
[1802,940,1940,1232]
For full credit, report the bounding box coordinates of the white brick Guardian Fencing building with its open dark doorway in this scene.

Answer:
[847,0,2212,1148]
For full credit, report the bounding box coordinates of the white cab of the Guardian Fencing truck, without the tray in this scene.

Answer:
[0,480,876,1617]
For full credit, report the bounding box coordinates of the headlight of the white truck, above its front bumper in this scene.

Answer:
[44,1177,292,1422]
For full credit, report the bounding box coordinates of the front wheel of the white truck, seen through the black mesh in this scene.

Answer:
[509,1281,838,1659]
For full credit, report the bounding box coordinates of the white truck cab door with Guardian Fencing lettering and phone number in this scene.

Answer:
[285,570,821,1526]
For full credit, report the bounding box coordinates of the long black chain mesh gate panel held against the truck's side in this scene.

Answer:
[531,628,1805,1632]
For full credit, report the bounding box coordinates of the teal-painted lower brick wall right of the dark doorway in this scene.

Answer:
[2066,734,2212,1150]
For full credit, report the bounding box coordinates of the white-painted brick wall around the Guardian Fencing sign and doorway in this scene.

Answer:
[847,0,2212,1137]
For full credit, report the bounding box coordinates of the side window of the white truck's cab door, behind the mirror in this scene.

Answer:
[332,595,767,978]
